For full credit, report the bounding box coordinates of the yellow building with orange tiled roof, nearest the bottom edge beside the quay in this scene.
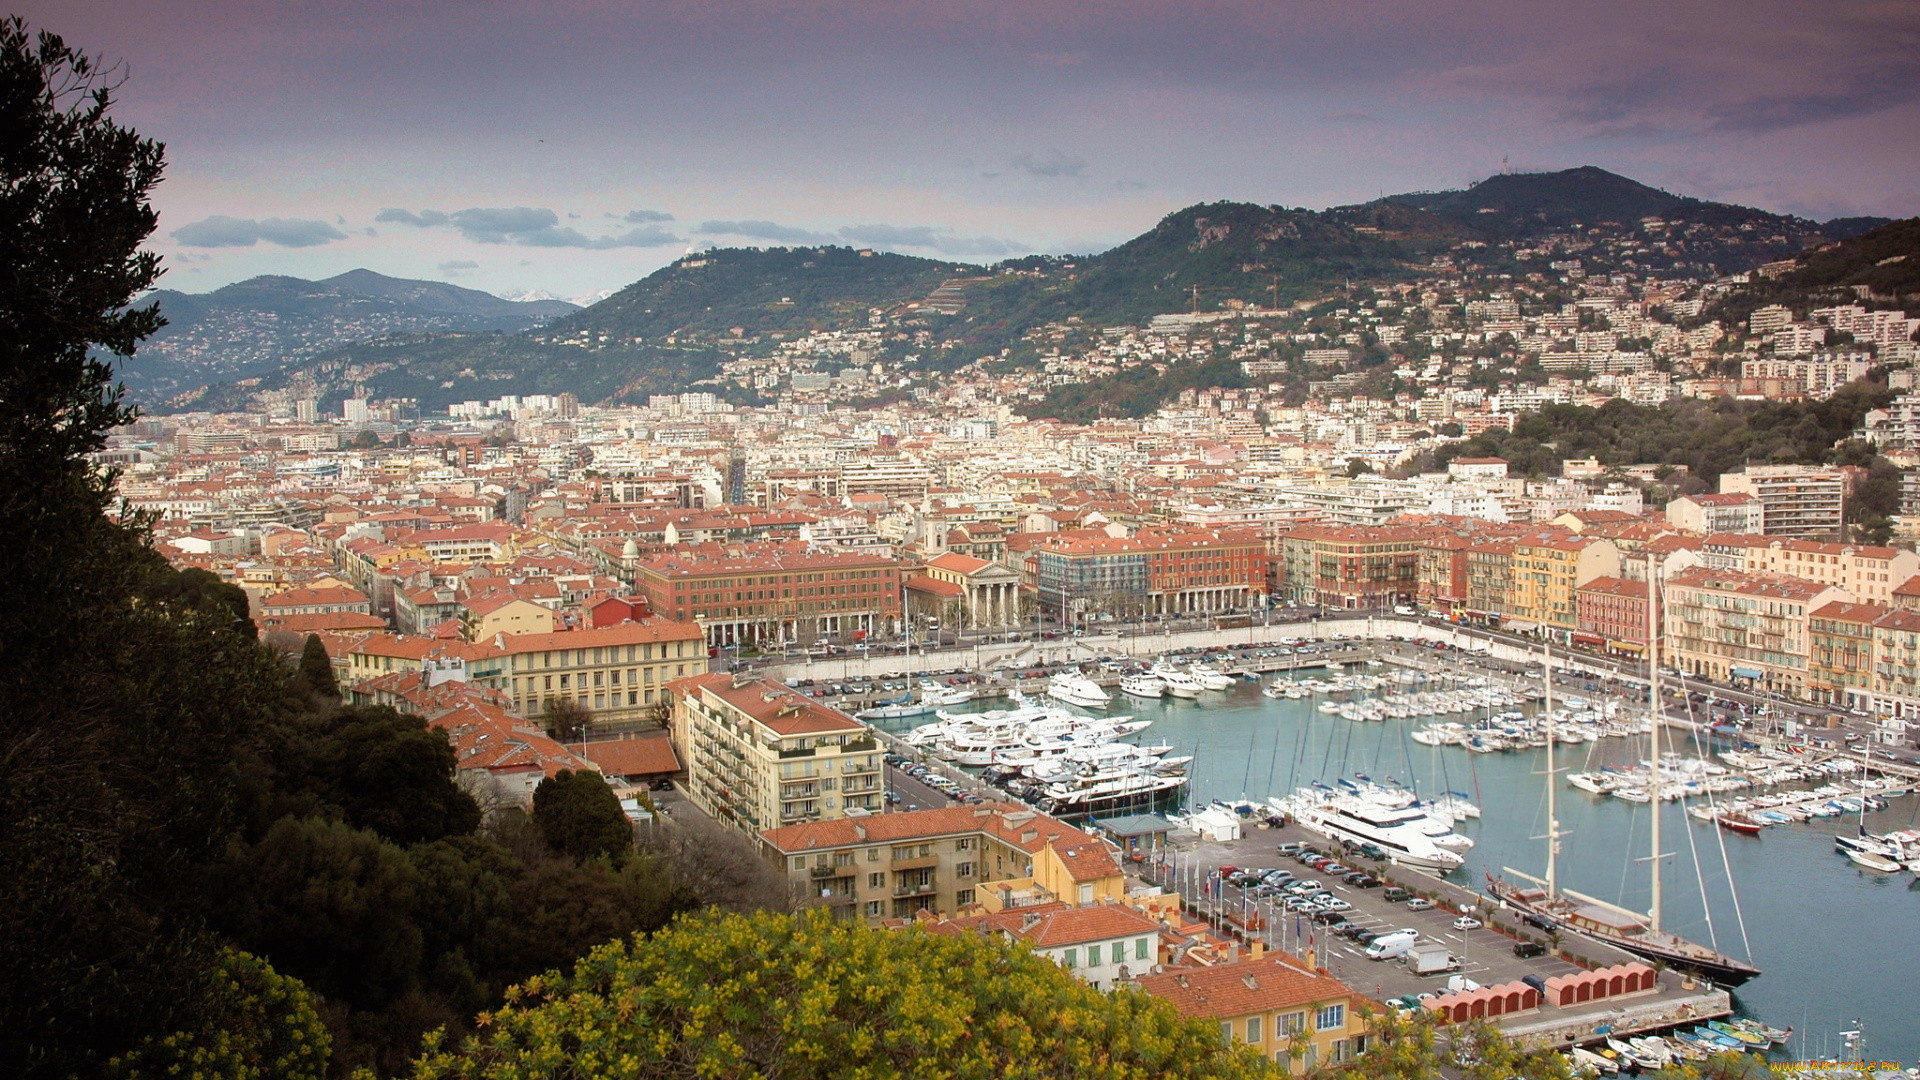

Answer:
[1135,953,1369,1074]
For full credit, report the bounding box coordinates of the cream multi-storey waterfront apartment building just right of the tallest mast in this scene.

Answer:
[1661,567,1857,698]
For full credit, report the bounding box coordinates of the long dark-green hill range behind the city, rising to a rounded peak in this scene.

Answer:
[182,167,1904,409]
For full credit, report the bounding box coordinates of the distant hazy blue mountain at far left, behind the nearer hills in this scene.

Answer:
[121,269,578,402]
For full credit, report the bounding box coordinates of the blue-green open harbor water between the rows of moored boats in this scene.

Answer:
[887,669,1920,1067]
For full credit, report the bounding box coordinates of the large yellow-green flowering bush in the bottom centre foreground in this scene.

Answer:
[415,911,1269,1080]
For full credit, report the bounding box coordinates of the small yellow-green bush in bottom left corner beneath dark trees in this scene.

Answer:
[108,949,332,1080]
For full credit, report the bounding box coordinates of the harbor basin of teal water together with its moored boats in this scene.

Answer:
[844,642,1920,1061]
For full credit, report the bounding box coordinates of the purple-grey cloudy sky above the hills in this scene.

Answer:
[26,0,1920,298]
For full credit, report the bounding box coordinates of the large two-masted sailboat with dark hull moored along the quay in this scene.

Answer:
[1486,595,1761,986]
